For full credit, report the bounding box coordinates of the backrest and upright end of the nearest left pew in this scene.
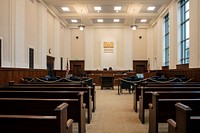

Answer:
[0,103,68,133]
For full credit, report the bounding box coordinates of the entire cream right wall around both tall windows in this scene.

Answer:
[147,0,200,70]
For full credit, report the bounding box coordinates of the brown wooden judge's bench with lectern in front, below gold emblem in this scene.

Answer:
[85,70,136,85]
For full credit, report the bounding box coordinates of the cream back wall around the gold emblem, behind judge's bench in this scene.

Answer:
[70,27,147,70]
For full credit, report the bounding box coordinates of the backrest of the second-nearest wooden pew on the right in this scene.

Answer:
[152,91,200,122]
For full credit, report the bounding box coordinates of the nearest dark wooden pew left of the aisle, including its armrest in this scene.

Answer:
[0,98,73,133]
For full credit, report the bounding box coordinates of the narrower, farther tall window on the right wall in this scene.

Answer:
[163,14,169,66]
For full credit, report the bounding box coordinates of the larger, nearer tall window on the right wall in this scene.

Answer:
[180,0,190,64]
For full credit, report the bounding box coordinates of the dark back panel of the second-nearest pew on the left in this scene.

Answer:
[0,98,72,116]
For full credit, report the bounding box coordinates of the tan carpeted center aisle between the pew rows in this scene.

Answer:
[86,86,148,133]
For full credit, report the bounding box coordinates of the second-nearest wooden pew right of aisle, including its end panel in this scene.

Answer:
[149,91,200,133]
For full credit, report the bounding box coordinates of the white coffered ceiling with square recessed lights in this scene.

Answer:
[43,0,172,28]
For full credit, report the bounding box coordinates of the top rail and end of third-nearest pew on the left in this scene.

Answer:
[0,86,92,123]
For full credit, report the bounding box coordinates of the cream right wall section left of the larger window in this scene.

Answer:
[147,0,178,70]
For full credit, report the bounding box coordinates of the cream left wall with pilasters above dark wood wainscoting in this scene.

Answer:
[0,0,70,69]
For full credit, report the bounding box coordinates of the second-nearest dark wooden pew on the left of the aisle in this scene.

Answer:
[0,90,86,133]
